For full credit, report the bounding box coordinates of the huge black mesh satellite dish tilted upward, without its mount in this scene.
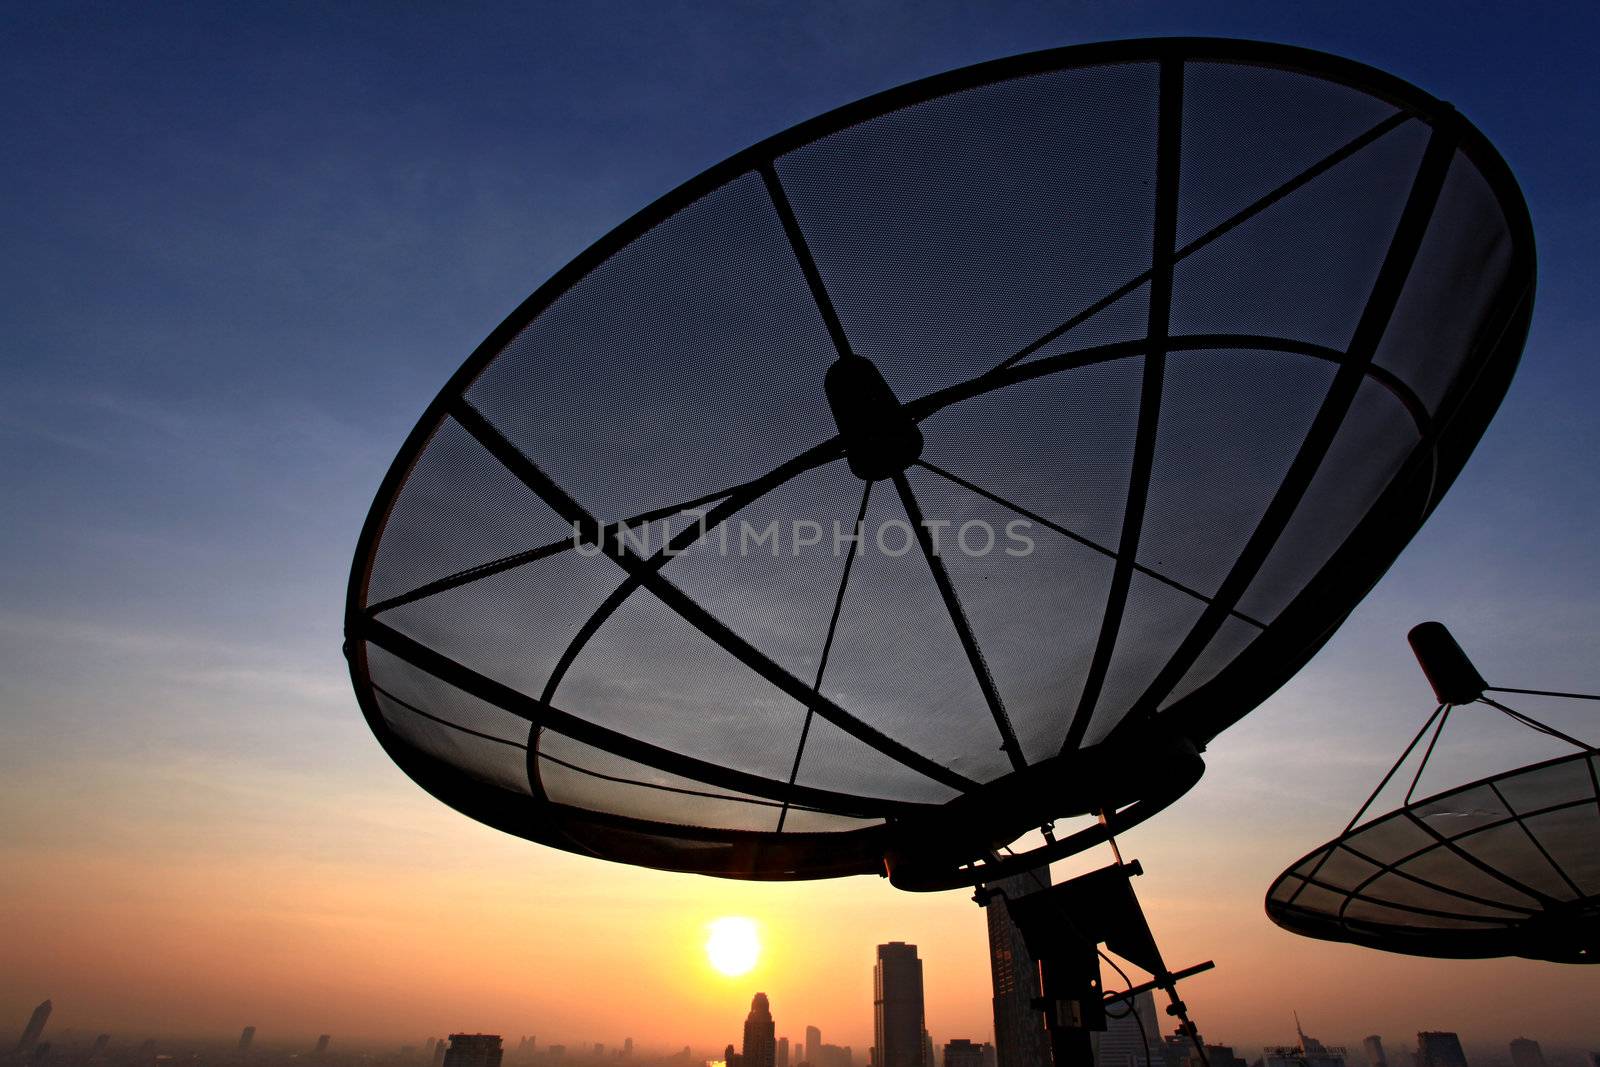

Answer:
[346,40,1534,889]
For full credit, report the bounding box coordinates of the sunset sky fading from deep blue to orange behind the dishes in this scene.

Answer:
[0,0,1600,1051]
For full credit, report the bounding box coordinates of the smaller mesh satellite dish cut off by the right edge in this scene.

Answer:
[1267,622,1600,963]
